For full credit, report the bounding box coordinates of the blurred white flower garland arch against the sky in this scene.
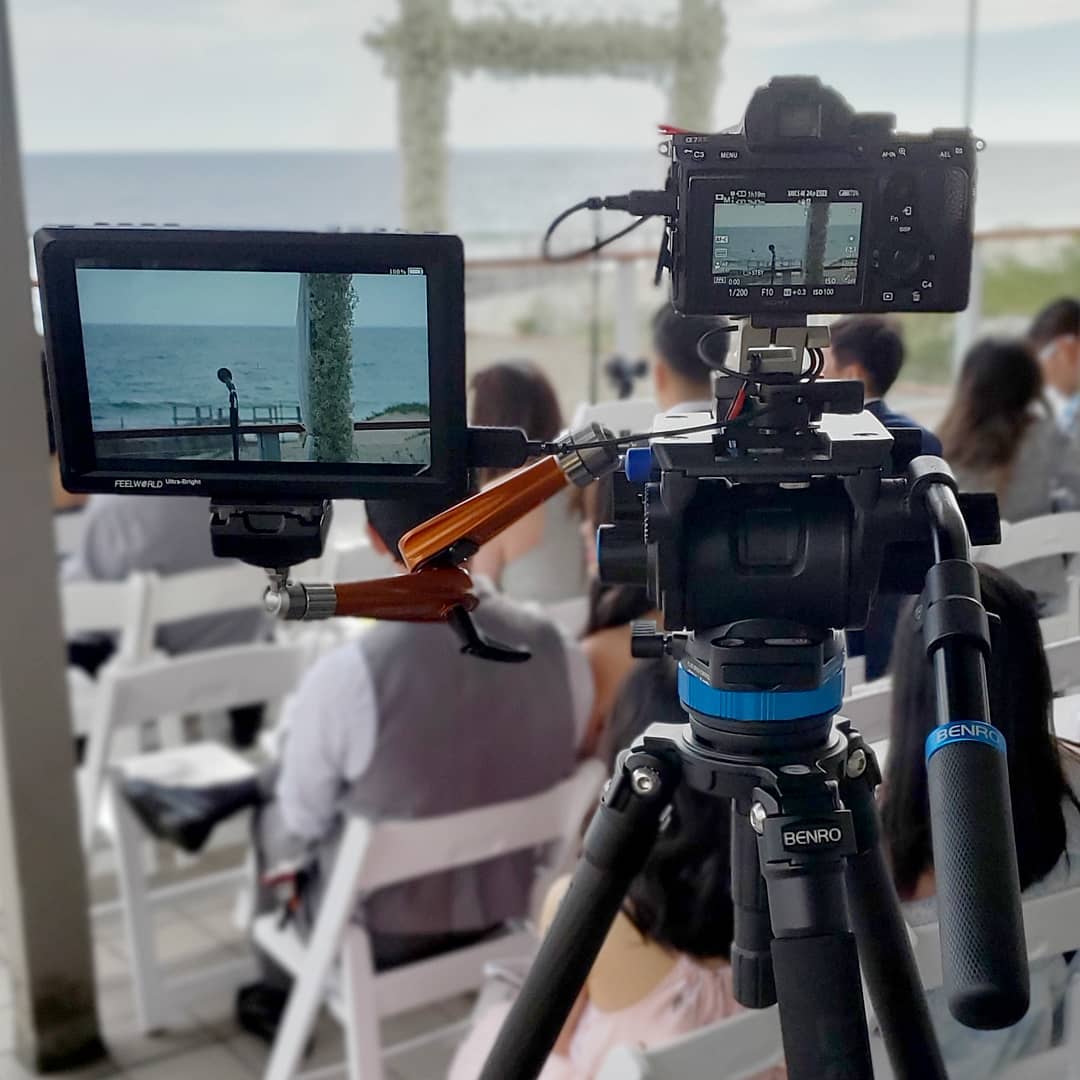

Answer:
[367,0,726,229]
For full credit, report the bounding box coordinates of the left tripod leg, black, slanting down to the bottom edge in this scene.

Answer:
[481,752,679,1080]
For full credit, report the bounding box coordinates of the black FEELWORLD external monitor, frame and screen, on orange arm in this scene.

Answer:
[36,228,467,502]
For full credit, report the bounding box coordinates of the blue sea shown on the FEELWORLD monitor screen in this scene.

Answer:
[83,324,428,431]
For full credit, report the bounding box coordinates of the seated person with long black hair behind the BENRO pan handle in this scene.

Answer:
[881,566,1080,1080]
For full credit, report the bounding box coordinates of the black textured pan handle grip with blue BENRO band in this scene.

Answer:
[927,724,1029,1029]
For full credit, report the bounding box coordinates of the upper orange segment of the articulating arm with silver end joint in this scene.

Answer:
[397,424,619,571]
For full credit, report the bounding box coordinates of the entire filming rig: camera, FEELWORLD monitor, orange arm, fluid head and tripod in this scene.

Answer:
[37,78,1028,1080]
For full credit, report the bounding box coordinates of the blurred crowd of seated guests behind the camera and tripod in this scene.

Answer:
[50,298,1080,1080]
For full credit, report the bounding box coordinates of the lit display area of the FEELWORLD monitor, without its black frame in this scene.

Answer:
[76,266,431,470]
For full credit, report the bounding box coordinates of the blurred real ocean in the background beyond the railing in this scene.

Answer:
[24,143,1080,256]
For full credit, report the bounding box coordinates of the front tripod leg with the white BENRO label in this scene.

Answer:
[754,770,874,1080]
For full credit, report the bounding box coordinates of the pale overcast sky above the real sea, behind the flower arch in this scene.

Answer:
[9,0,1080,151]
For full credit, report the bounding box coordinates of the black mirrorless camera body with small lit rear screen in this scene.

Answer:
[667,77,977,318]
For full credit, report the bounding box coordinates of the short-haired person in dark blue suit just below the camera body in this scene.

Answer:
[822,315,942,457]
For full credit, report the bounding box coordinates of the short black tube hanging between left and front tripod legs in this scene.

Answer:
[731,799,777,1009]
